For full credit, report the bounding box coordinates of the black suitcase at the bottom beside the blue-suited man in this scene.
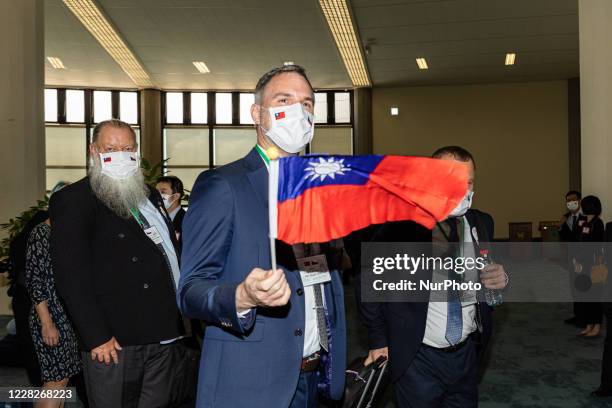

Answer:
[342,357,389,408]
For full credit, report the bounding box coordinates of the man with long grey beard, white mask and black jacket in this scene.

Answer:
[50,120,185,408]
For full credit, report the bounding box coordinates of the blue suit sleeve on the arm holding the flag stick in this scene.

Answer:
[177,171,255,334]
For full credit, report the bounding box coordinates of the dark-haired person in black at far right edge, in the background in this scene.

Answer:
[572,195,605,338]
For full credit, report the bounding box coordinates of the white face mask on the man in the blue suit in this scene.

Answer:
[260,103,314,153]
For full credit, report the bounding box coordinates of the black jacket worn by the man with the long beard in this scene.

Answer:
[49,178,184,350]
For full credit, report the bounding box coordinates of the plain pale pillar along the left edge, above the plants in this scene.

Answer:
[0,0,45,314]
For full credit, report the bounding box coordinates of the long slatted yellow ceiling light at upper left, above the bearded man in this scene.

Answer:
[64,0,153,88]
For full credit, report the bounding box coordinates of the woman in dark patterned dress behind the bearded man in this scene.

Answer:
[26,183,81,408]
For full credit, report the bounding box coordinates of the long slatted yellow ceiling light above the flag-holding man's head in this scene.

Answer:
[319,0,371,87]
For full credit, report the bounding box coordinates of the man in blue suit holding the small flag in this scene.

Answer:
[177,65,346,408]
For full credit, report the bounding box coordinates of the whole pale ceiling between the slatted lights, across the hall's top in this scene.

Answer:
[45,0,578,89]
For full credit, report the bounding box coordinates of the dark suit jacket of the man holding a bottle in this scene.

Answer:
[357,210,493,381]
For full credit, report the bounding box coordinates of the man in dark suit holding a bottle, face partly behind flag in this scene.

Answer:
[356,146,508,408]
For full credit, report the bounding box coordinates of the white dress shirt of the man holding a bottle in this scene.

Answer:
[423,217,477,348]
